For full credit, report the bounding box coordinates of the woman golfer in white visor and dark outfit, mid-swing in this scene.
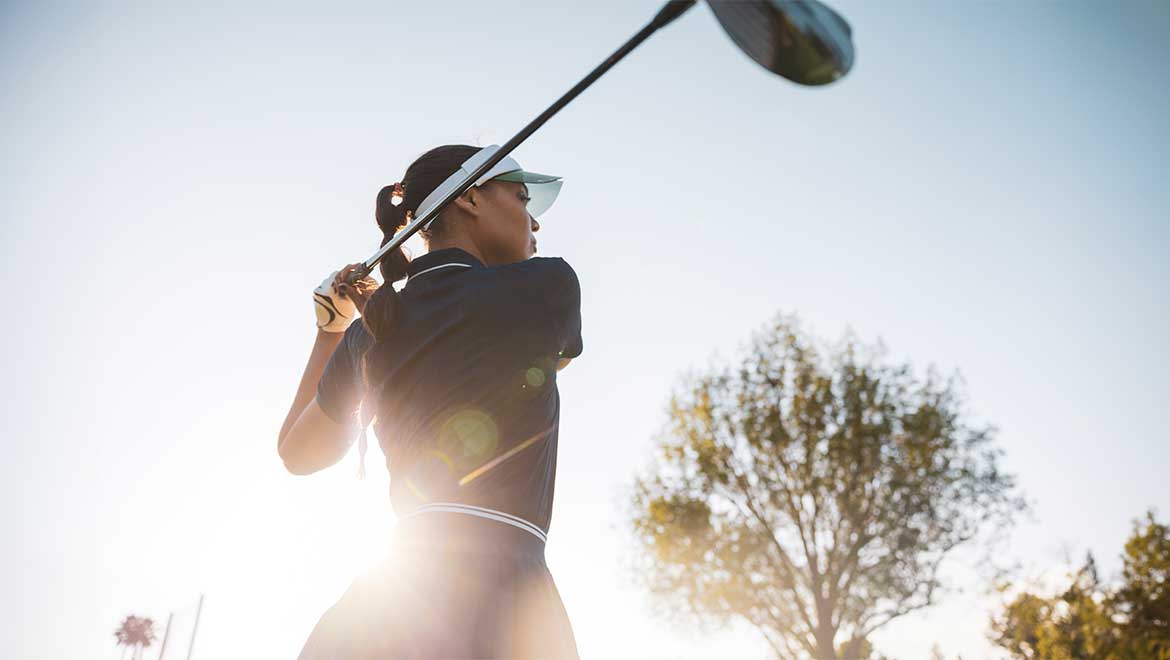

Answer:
[280,145,581,660]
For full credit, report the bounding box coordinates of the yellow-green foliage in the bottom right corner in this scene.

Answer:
[991,513,1170,660]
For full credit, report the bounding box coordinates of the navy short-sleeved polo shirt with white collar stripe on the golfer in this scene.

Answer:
[317,248,581,532]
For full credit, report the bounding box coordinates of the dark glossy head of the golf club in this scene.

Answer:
[708,0,853,85]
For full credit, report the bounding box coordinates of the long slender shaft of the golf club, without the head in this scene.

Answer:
[347,0,696,284]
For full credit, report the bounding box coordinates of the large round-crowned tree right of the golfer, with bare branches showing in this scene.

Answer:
[631,316,1024,659]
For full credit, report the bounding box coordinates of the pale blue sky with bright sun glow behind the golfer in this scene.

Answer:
[0,0,1170,659]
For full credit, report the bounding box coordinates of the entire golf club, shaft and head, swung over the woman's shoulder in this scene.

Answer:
[346,0,853,284]
